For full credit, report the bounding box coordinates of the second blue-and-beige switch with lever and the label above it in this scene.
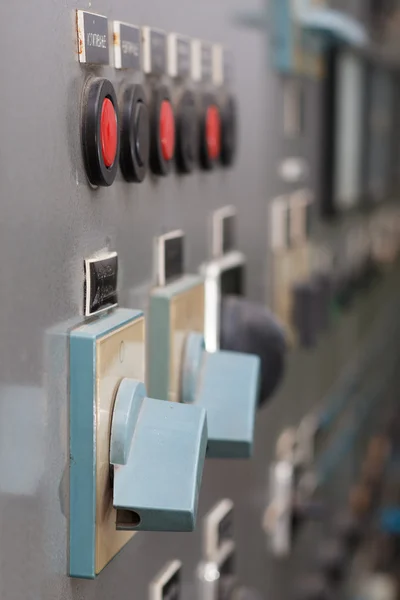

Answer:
[148,231,260,458]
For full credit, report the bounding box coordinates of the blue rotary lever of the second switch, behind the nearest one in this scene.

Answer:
[181,332,260,458]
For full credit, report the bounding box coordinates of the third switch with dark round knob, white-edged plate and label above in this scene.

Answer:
[200,206,286,404]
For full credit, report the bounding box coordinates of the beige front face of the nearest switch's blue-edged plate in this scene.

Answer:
[95,318,145,573]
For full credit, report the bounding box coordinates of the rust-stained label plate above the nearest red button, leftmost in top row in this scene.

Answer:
[76,10,110,65]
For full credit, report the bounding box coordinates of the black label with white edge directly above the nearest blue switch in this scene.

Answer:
[84,252,118,316]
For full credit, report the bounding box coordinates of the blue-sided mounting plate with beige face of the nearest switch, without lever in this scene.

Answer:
[69,309,145,579]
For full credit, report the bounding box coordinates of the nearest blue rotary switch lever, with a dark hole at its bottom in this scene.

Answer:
[110,378,207,531]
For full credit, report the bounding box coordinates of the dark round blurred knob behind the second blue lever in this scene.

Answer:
[220,296,286,404]
